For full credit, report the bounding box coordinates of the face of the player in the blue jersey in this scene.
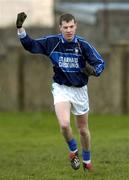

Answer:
[59,20,77,41]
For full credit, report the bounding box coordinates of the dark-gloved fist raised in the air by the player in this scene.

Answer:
[16,12,27,28]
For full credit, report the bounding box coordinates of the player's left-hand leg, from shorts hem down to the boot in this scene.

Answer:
[55,102,80,170]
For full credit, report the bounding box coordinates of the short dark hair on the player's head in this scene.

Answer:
[59,13,76,25]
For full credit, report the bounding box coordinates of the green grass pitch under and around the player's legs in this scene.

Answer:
[0,112,129,180]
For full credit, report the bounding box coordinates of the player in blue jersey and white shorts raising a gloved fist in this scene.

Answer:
[16,12,104,170]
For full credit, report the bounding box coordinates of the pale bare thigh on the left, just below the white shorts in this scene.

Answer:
[55,101,71,126]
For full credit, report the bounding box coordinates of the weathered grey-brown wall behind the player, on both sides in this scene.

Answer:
[0,42,129,114]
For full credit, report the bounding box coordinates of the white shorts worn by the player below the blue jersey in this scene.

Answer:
[52,82,89,115]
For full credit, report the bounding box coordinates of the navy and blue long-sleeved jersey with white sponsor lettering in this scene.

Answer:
[20,34,104,87]
